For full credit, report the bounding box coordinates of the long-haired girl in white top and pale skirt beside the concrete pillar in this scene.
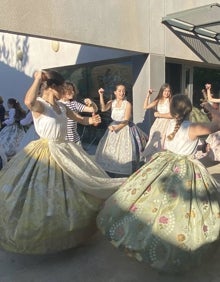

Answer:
[141,83,173,162]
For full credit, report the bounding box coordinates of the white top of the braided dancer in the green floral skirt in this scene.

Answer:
[164,120,198,155]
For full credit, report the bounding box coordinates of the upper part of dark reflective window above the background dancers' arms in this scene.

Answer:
[52,61,132,102]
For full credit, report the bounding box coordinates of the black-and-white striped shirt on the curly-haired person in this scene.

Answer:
[61,101,85,143]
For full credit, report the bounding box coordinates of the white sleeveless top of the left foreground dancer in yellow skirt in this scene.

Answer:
[33,97,67,140]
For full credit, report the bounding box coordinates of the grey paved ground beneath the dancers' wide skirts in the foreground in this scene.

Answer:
[0,150,220,282]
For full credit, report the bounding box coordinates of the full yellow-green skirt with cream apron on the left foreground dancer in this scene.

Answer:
[0,139,124,254]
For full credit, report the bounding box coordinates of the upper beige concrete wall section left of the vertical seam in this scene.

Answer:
[0,0,151,52]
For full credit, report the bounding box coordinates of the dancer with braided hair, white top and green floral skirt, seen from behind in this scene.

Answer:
[97,94,220,273]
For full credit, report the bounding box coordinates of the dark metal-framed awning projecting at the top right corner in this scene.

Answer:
[162,3,220,44]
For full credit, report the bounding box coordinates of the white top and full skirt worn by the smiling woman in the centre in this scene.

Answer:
[95,100,147,175]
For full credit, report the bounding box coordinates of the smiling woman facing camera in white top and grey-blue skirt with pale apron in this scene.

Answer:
[95,83,147,177]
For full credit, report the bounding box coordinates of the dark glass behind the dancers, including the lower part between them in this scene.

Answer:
[49,60,133,147]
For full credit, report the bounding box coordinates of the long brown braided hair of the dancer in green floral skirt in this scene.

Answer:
[167,94,192,140]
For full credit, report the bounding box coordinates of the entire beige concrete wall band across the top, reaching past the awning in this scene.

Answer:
[0,0,217,61]
